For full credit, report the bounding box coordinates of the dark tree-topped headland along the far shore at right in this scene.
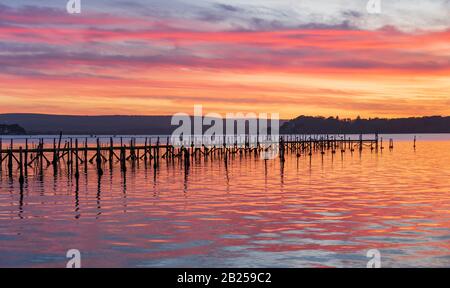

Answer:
[280,116,450,134]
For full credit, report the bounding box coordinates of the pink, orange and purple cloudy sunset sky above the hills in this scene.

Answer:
[0,0,450,119]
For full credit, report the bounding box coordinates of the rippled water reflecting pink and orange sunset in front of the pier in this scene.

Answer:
[0,135,450,267]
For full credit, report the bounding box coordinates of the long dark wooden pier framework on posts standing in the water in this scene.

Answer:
[0,134,386,184]
